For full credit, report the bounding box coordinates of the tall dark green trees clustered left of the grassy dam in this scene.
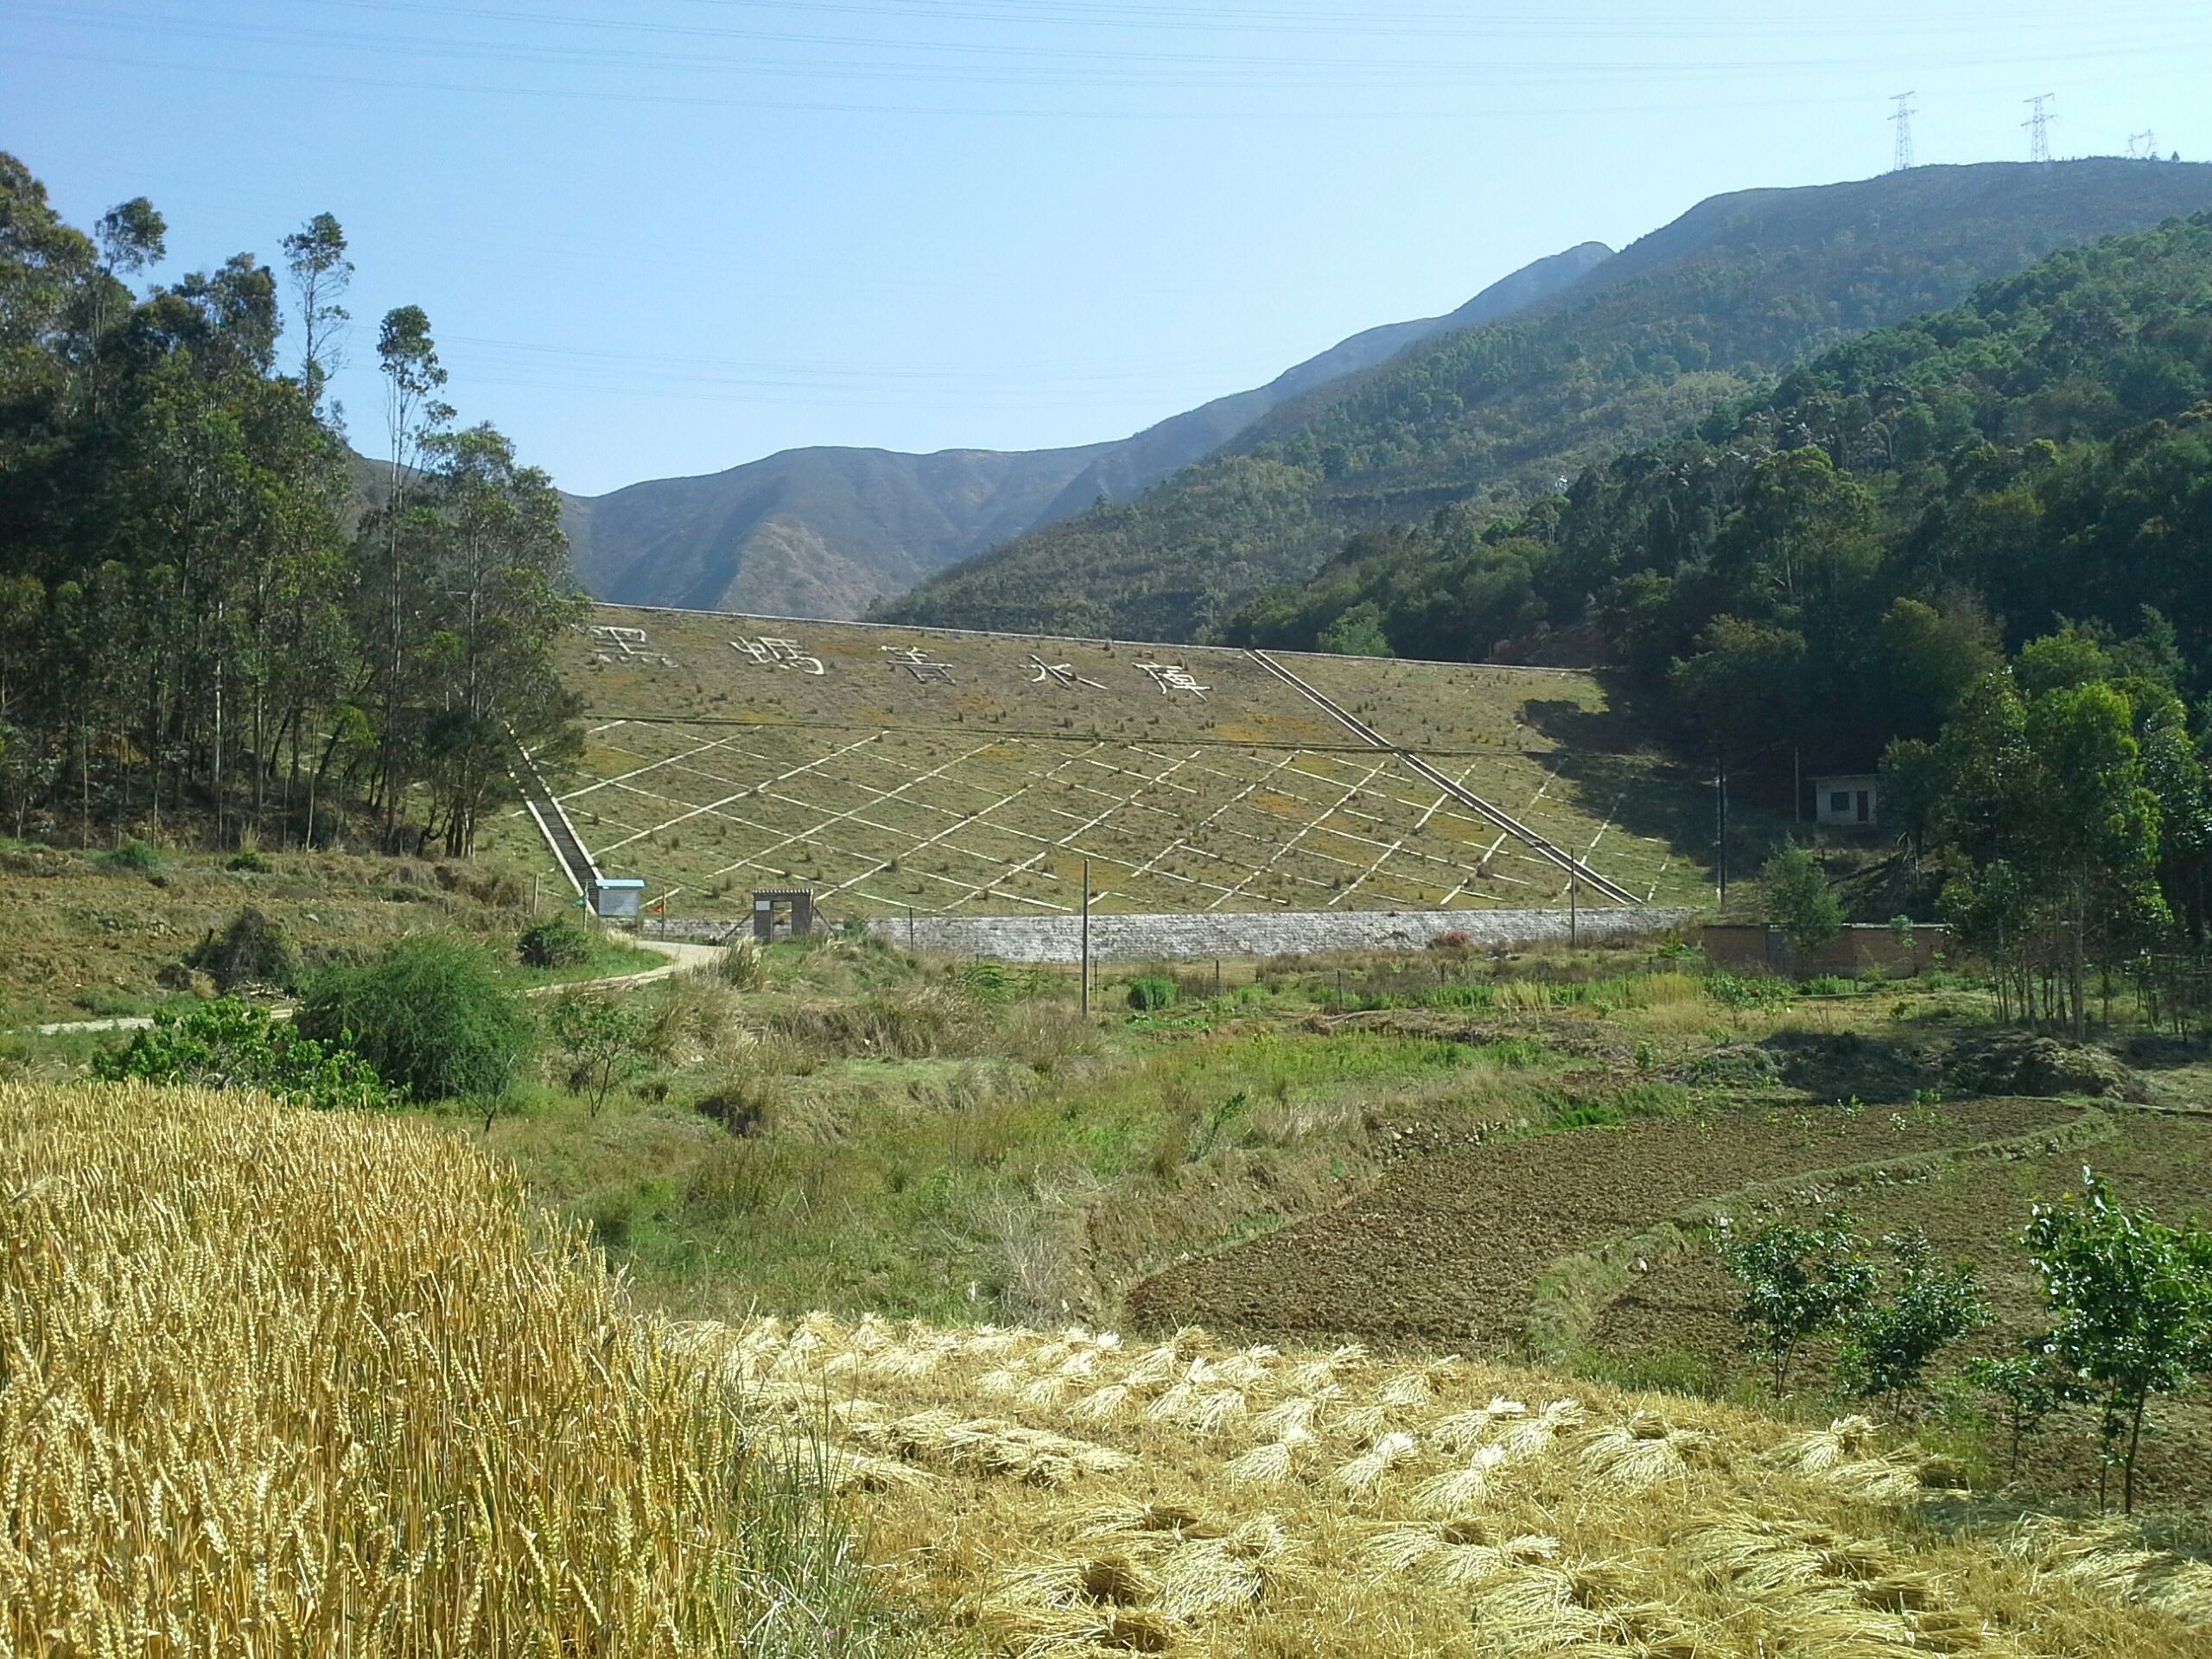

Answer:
[0,153,584,856]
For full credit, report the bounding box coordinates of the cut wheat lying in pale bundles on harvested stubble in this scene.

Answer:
[686,1316,2212,1659]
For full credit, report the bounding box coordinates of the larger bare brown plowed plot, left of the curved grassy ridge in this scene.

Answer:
[1128,1099,2079,1350]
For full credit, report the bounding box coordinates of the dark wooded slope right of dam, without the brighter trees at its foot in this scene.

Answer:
[1224,213,2212,814]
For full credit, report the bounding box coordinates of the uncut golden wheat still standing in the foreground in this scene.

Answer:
[0,1086,872,1656]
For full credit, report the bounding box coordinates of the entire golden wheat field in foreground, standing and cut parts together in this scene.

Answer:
[17,1086,2212,1659]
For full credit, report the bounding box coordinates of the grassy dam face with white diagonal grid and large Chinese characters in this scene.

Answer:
[475,606,1706,916]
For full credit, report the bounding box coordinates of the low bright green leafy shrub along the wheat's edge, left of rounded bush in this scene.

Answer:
[93,998,407,1109]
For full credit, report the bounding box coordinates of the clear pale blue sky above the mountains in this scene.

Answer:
[0,0,2212,493]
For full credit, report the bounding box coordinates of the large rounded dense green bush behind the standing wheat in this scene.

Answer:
[299,936,536,1099]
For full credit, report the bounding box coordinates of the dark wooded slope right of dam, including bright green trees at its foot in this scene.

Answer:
[1230,203,2212,1028]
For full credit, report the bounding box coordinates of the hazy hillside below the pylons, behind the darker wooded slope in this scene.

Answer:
[878,162,2212,651]
